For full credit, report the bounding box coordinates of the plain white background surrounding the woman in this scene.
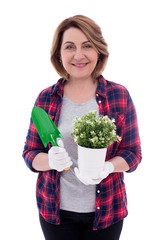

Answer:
[0,0,160,240]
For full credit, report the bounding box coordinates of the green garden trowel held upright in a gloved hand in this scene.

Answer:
[32,107,69,170]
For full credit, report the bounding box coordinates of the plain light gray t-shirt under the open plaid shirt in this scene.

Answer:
[58,95,99,213]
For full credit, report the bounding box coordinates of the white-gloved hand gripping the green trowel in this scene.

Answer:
[48,139,73,172]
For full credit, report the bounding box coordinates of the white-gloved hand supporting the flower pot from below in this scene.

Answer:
[74,162,114,185]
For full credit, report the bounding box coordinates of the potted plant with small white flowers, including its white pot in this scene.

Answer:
[72,111,121,179]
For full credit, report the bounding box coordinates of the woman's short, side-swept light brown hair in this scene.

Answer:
[51,15,109,80]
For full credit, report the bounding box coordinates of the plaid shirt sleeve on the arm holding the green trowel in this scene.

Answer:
[22,92,46,172]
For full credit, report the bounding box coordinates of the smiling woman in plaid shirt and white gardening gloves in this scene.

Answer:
[23,15,141,240]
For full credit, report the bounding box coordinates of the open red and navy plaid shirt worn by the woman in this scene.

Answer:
[23,76,141,230]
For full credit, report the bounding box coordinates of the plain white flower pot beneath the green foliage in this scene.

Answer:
[78,145,107,179]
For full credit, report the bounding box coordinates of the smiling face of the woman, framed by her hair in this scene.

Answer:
[60,27,98,79]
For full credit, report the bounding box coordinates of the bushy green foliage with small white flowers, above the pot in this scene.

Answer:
[72,110,121,148]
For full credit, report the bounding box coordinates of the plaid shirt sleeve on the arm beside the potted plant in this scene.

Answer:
[116,92,142,172]
